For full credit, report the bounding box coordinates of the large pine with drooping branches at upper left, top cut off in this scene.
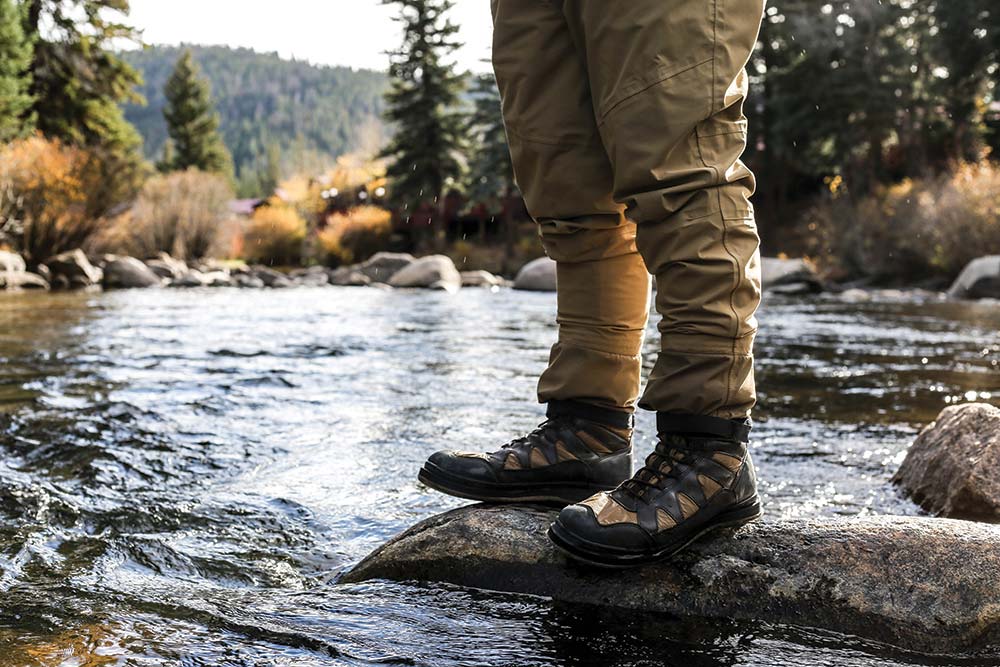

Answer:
[24,0,146,216]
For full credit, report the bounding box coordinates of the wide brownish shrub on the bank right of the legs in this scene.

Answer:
[807,162,1000,281]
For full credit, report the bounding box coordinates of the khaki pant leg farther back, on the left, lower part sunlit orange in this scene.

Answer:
[493,0,650,409]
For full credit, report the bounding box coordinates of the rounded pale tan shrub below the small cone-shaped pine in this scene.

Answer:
[129,169,233,259]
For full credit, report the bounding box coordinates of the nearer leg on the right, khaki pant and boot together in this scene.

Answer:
[553,0,763,564]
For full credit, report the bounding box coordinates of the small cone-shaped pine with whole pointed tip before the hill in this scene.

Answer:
[163,51,233,174]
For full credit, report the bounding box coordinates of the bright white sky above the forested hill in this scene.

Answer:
[130,0,492,71]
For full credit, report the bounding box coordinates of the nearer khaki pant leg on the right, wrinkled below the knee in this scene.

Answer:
[562,0,763,418]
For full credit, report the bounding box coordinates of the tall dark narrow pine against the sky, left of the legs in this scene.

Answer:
[381,0,465,244]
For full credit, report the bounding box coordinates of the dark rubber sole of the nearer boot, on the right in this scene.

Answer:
[548,497,763,570]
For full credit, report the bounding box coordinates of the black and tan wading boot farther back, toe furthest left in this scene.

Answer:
[418,401,632,505]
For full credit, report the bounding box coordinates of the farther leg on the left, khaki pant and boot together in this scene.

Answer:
[420,0,650,503]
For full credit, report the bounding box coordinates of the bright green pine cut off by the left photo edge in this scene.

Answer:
[0,0,35,142]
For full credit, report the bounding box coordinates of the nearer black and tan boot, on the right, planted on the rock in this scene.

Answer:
[549,414,761,567]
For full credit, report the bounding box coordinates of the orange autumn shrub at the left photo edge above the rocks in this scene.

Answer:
[0,136,108,266]
